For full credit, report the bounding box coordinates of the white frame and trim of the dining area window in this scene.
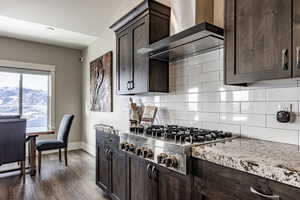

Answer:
[0,59,55,129]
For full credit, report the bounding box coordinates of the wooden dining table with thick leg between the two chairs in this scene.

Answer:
[26,130,55,176]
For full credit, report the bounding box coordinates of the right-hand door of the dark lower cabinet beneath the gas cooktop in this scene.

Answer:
[153,167,192,200]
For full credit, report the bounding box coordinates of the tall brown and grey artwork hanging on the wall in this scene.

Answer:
[90,51,113,112]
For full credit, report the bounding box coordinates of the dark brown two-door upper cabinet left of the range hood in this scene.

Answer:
[110,0,170,95]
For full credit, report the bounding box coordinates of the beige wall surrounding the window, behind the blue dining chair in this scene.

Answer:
[0,37,82,142]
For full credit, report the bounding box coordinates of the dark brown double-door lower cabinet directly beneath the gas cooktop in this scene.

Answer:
[128,156,192,200]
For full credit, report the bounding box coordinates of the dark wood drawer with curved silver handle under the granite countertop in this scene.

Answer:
[193,159,300,200]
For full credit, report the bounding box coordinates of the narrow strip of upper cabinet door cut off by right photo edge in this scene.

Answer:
[293,0,300,77]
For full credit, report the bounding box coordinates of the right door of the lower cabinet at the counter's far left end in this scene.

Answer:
[111,149,127,200]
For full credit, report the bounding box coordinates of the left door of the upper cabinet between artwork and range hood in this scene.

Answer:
[117,29,133,94]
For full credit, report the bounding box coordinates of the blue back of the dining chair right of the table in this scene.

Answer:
[57,115,74,145]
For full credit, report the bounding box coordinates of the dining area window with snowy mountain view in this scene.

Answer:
[0,67,53,131]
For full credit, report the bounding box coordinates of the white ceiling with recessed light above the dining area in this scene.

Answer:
[0,0,169,49]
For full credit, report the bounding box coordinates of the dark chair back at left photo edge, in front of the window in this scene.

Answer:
[0,119,26,165]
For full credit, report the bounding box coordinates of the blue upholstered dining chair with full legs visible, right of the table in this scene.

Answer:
[36,114,74,172]
